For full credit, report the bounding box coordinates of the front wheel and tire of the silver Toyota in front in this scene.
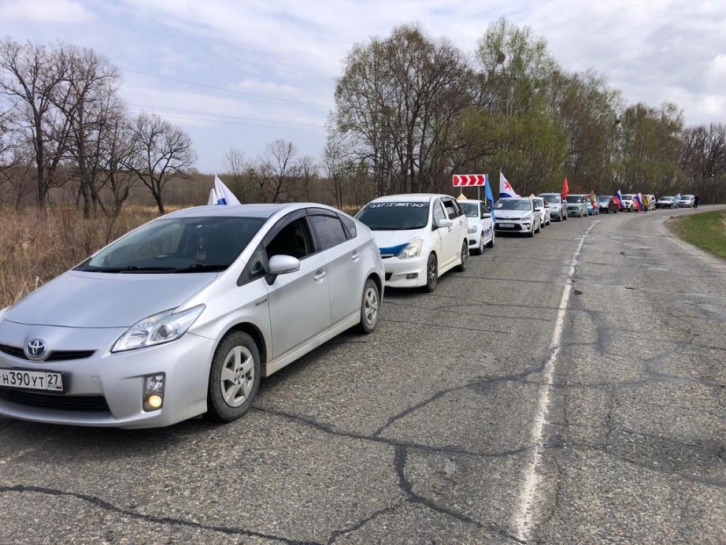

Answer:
[204,331,262,422]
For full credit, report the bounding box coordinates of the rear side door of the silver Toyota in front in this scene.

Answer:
[309,209,365,327]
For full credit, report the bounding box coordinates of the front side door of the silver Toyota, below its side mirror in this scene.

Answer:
[263,210,330,359]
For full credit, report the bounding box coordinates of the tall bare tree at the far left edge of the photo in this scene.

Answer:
[0,38,74,210]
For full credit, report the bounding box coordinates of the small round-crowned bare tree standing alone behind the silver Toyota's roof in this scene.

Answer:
[125,114,197,214]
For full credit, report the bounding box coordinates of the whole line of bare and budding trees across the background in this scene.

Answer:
[0,19,726,217]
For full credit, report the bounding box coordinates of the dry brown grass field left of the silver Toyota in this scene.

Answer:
[0,206,166,308]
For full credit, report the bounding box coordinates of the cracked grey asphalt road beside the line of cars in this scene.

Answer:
[0,205,726,545]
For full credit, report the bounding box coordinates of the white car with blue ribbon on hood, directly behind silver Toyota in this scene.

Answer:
[356,193,469,292]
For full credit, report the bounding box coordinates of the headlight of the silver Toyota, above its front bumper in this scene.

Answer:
[111,305,205,352]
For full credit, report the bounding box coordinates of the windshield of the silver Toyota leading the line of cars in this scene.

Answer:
[75,216,265,273]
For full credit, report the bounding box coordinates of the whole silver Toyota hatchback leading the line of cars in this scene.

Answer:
[0,204,384,428]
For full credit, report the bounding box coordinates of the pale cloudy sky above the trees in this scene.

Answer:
[0,0,726,173]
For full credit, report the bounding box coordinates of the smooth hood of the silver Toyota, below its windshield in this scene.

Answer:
[6,271,217,328]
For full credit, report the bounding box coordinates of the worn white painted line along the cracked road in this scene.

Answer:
[514,220,601,542]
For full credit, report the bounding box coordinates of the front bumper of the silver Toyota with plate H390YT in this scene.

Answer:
[0,322,214,428]
